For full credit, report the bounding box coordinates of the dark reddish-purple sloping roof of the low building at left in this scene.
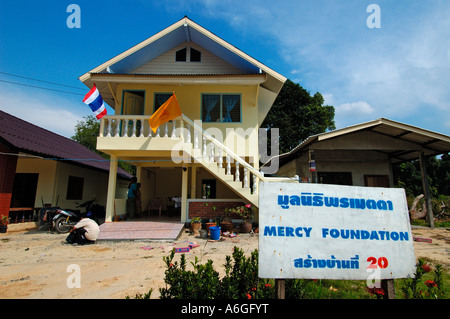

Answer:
[0,111,131,178]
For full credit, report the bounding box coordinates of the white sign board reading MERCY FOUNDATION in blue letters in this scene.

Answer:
[259,183,416,280]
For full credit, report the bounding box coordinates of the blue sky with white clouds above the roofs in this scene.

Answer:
[0,0,450,136]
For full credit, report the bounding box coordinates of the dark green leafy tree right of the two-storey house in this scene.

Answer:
[261,80,336,154]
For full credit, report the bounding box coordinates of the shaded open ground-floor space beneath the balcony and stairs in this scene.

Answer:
[110,162,247,222]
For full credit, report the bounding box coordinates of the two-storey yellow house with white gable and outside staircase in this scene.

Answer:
[80,17,286,222]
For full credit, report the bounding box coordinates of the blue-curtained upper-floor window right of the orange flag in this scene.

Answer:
[202,94,241,123]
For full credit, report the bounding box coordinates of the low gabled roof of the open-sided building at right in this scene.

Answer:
[272,118,450,164]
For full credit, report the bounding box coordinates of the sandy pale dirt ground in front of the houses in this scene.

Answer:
[0,228,450,299]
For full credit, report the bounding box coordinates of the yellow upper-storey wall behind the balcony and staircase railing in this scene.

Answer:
[116,84,258,164]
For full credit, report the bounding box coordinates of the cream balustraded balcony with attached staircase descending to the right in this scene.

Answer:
[97,115,298,206]
